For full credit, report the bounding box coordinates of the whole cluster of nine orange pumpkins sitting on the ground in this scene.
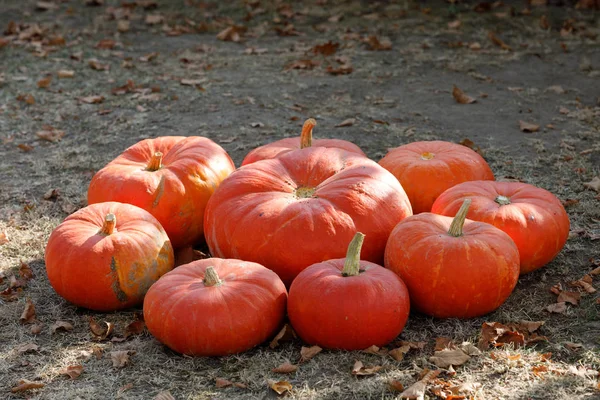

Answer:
[45,119,569,356]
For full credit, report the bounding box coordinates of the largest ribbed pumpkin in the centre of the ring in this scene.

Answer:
[204,147,412,285]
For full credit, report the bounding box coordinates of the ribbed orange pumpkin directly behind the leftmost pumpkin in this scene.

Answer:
[88,136,235,248]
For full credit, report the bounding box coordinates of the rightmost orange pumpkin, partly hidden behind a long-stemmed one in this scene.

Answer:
[431,181,570,274]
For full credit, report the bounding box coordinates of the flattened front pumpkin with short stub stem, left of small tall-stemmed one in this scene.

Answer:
[144,258,287,356]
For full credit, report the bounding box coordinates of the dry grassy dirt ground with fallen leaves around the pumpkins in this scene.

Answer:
[0,0,600,399]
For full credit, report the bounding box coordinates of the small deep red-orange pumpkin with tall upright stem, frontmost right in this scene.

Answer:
[288,233,410,350]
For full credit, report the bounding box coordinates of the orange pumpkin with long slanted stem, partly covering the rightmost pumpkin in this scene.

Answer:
[385,200,519,318]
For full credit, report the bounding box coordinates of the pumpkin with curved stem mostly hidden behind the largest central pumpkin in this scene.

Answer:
[242,118,366,165]
